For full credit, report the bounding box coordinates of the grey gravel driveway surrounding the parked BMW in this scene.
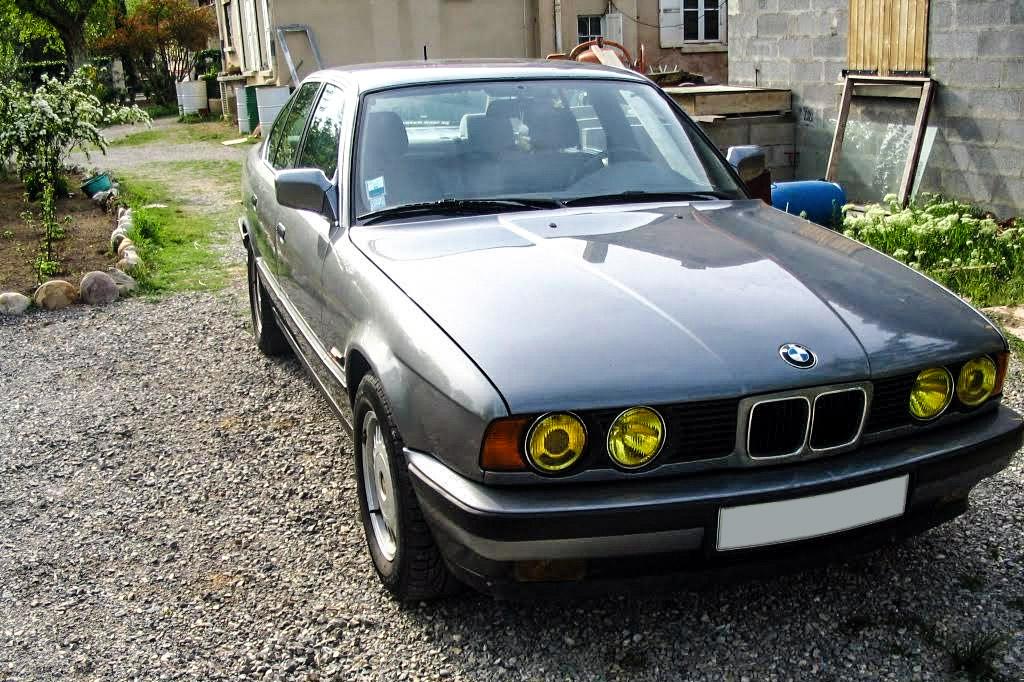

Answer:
[0,286,1024,681]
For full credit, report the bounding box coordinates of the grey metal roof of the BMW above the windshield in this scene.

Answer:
[308,59,647,92]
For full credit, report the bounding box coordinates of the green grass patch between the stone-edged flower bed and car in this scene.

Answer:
[119,157,244,294]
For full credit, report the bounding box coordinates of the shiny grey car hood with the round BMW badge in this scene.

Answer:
[350,201,1005,413]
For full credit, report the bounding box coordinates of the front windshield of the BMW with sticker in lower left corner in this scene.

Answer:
[352,79,745,217]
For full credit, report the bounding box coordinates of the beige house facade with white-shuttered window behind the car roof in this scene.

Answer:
[214,0,728,85]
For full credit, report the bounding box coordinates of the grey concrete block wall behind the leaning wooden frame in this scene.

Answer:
[729,0,1024,217]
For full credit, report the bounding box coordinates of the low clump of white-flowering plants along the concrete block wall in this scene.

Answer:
[843,195,1024,305]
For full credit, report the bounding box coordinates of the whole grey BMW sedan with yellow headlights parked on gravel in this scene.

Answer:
[239,60,1022,599]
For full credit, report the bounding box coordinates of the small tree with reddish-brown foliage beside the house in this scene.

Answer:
[96,0,217,102]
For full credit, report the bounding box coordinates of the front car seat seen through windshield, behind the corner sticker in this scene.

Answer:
[358,112,440,213]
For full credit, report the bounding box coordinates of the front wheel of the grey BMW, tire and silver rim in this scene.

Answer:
[352,375,459,601]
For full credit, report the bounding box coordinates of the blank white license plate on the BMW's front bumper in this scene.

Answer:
[718,476,909,550]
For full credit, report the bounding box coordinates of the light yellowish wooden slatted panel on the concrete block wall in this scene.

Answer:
[847,0,928,76]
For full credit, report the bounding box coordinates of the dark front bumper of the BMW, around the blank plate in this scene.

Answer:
[406,407,1024,594]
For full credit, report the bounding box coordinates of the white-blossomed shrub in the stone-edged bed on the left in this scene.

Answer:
[0,70,150,198]
